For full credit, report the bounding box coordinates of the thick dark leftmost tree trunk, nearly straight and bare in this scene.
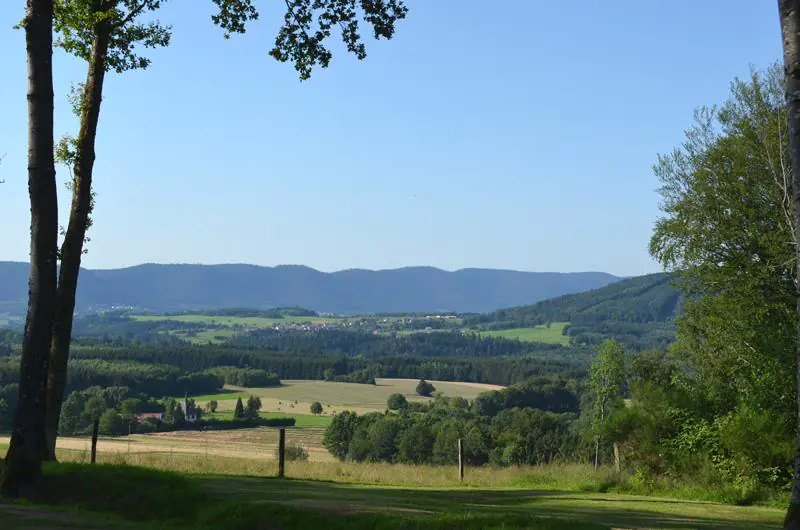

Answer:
[0,0,58,496]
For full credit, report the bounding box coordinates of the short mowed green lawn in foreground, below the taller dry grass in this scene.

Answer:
[0,463,782,530]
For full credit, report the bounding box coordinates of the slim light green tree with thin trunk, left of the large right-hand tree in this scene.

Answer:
[588,340,625,469]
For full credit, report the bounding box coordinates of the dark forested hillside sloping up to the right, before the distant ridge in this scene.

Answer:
[465,274,682,349]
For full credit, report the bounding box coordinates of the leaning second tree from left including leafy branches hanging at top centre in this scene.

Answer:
[40,0,407,459]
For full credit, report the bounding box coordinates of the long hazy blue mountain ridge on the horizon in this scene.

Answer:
[0,262,620,315]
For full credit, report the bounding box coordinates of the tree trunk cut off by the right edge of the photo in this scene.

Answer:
[778,0,800,529]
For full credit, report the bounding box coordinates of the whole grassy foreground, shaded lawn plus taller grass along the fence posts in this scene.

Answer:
[0,451,783,530]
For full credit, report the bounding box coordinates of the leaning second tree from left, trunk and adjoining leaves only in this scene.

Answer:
[45,0,170,460]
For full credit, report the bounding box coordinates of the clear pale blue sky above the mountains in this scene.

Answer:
[0,0,781,275]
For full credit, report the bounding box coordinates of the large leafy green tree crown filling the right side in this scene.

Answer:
[650,66,796,414]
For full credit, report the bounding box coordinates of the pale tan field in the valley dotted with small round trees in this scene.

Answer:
[194,379,502,415]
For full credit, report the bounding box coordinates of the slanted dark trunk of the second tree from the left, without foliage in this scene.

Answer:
[45,20,111,460]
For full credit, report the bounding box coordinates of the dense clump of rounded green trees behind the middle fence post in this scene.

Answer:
[324,378,591,465]
